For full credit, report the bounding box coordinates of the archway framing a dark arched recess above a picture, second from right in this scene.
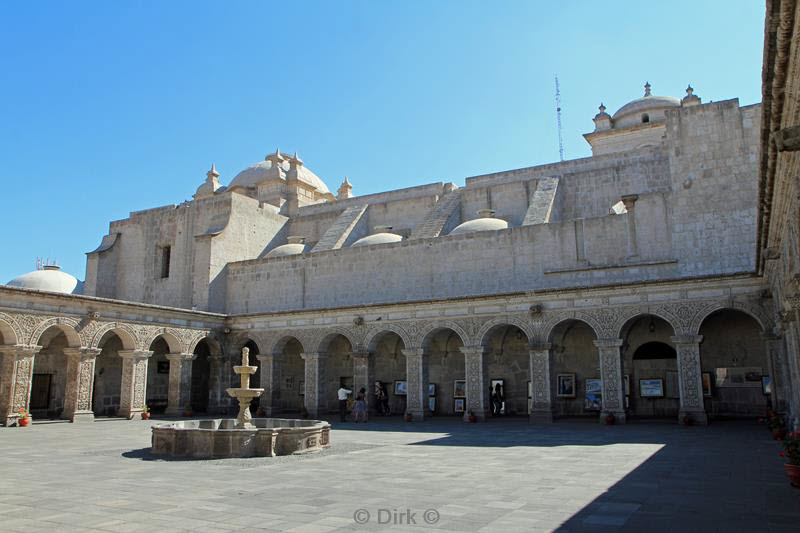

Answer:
[620,314,680,419]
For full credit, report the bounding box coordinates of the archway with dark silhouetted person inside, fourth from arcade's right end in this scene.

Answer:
[481,324,531,416]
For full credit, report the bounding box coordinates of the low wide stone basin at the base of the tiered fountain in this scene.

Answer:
[152,418,331,459]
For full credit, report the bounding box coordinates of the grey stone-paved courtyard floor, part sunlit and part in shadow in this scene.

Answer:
[0,419,800,532]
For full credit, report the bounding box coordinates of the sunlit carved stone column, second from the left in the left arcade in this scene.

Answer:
[61,348,101,422]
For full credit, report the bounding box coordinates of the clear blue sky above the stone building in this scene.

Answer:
[0,0,764,283]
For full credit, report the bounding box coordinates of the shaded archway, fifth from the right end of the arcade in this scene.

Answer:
[422,327,467,416]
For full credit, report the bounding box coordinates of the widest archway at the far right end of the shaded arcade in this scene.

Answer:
[699,309,769,417]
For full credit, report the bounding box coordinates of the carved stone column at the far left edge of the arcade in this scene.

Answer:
[0,345,42,426]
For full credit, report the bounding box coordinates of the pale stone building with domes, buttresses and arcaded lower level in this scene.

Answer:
[0,67,800,424]
